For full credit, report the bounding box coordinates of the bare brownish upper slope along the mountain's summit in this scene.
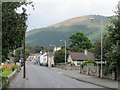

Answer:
[50,15,103,28]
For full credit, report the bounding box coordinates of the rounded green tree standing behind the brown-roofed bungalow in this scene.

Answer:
[69,32,92,51]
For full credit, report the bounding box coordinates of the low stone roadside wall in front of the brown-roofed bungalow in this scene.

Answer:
[56,64,114,80]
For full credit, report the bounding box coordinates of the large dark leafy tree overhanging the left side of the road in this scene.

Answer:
[2,2,31,62]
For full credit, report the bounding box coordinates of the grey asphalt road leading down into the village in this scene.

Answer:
[9,61,102,88]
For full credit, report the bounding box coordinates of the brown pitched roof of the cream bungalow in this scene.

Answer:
[69,52,94,61]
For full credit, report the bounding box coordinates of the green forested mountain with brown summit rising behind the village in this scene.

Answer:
[26,15,109,47]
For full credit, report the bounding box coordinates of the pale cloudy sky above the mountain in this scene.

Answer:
[27,0,120,31]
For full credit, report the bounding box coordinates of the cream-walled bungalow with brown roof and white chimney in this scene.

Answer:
[67,50,95,66]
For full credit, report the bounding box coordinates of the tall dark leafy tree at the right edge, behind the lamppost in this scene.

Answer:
[105,1,120,80]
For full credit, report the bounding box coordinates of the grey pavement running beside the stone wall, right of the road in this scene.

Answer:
[51,68,119,89]
